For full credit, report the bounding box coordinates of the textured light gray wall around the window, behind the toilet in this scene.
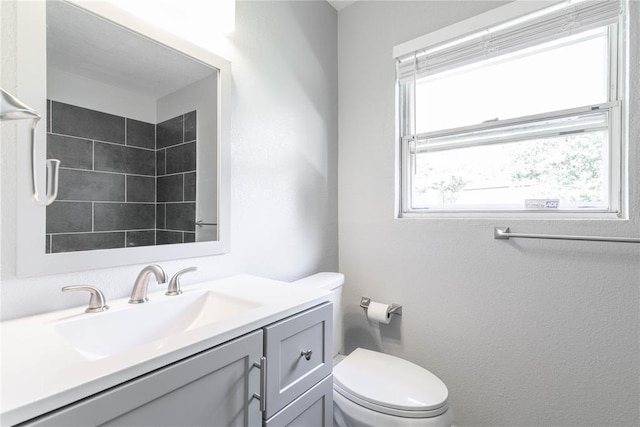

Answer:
[338,1,640,426]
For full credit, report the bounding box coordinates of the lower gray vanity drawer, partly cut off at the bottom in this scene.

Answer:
[264,375,333,427]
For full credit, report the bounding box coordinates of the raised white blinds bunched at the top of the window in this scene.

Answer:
[397,0,621,83]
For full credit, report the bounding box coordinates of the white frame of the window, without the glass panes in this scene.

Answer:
[394,0,629,219]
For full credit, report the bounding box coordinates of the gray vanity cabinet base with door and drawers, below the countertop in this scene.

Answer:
[21,303,333,427]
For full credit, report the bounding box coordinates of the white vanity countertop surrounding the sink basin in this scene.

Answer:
[0,275,330,426]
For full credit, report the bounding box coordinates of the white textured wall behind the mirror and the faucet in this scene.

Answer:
[0,1,338,319]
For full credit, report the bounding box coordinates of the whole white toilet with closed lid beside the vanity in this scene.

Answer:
[295,273,452,427]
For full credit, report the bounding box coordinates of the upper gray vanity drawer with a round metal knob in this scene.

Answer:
[264,303,333,419]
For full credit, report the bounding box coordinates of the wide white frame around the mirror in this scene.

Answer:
[16,1,231,277]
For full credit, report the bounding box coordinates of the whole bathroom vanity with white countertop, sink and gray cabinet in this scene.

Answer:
[0,275,333,427]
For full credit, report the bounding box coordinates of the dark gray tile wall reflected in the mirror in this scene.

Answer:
[46,100,197,253]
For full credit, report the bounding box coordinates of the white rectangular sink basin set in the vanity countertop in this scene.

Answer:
[53,291,260,360]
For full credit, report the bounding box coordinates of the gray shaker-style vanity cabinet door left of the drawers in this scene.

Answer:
[27,331,262,427]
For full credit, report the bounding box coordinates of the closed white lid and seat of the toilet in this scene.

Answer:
[333,348,449,418]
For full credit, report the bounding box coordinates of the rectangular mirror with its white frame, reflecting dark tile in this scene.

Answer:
[17,0,230,276]
